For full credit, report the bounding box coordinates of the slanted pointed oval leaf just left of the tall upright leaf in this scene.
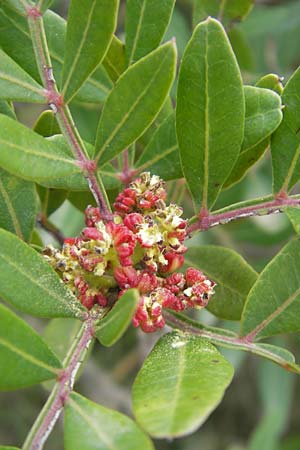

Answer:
[96,42,176,166]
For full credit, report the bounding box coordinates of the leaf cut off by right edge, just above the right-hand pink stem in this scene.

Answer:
[271,68,300,193]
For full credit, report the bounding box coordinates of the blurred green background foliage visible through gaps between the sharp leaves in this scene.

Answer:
[0,0,300,450]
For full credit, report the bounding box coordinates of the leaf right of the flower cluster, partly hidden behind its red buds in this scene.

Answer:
[185,245,257,320]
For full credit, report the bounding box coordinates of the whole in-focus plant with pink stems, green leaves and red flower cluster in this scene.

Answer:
[0,0,300,450]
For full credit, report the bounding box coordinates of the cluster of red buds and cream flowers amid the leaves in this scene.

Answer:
[44,172,215,333]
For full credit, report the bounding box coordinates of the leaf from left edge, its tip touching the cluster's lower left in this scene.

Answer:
[0,230,84,318]
